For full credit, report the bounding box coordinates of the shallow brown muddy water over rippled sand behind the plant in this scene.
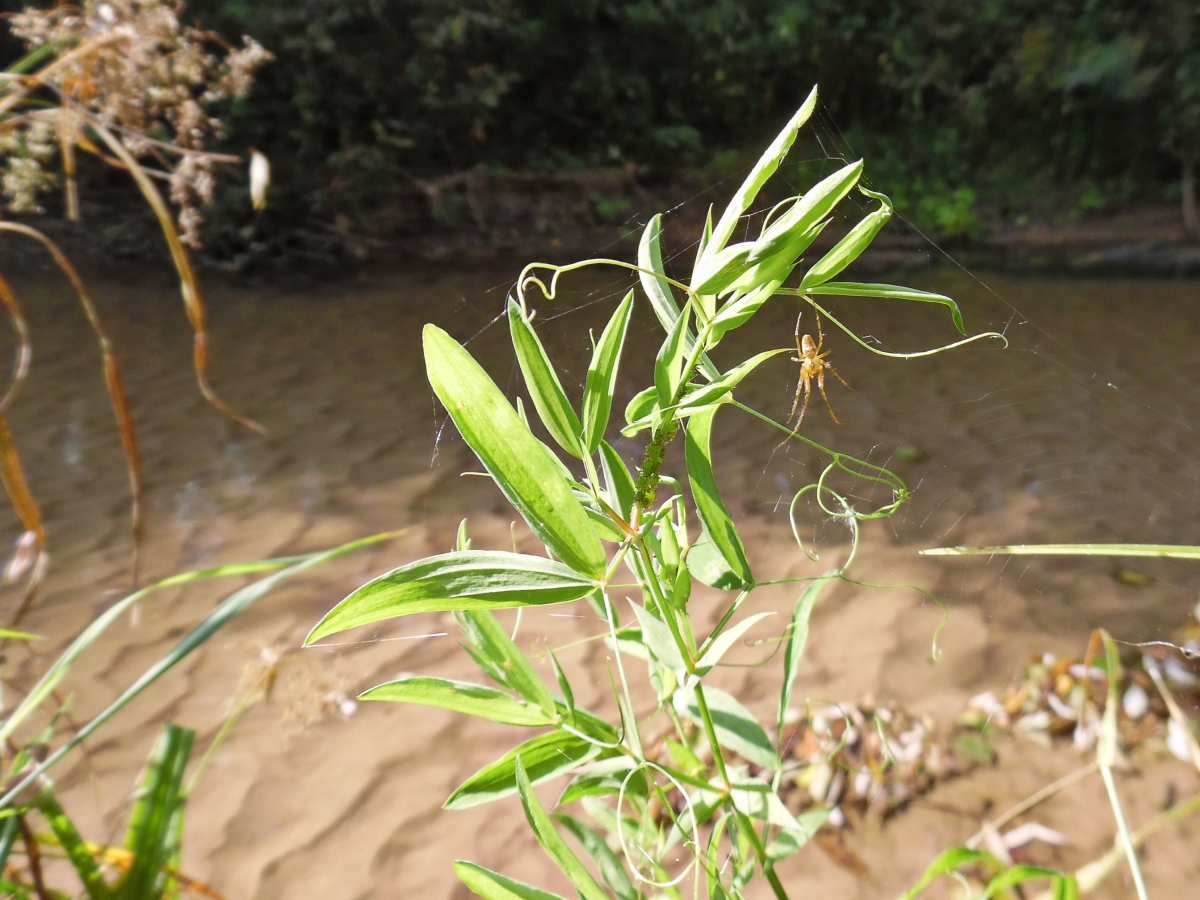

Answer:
[2,270,1200,899]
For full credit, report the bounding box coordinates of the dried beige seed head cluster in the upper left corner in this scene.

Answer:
[0,0,271,244]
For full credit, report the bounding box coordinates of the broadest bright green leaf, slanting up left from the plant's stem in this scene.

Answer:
[424,325,606,578]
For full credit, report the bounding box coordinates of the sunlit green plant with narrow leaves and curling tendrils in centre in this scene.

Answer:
[307,90,1003,900]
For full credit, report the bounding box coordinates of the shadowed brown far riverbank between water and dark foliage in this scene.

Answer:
[9,167,1200,281]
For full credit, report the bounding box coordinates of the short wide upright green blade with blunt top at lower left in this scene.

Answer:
[116,725,196,900]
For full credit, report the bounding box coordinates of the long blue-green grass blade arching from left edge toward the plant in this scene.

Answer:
[0,532,395,810]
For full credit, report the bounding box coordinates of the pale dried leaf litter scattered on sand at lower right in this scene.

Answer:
[673,608,1200,872]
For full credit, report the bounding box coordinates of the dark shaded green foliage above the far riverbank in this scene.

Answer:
[177,0,1200,243]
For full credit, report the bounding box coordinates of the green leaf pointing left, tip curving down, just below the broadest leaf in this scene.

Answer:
[305,554,595,644]
